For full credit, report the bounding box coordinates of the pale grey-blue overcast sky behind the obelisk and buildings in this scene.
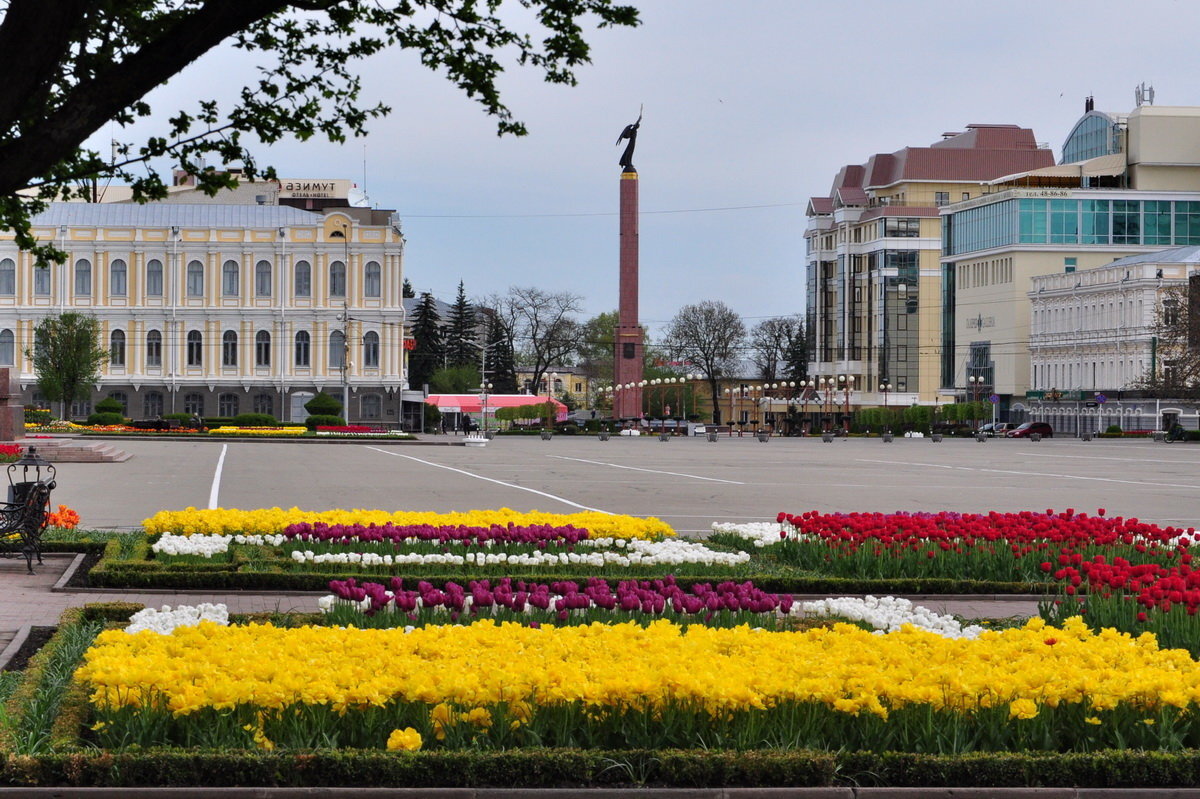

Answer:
[88,0,1200,335]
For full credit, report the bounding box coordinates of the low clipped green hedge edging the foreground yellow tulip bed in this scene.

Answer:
[7,602,1200,782]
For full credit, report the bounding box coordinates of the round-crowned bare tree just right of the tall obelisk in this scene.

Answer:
[665,300,746,423]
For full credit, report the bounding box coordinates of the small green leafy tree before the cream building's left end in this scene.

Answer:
[25,312,108,419]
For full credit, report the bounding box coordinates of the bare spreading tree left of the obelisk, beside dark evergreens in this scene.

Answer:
[486,286,583,386]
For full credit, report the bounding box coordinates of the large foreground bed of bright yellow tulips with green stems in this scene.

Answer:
[76,611,1200,752]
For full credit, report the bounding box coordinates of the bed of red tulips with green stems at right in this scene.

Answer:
[748,509,1200,656]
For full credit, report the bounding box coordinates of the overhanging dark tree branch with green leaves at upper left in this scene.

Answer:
[0,0,637,260]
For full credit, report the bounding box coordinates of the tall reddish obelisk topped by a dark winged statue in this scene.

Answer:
[612,114,644,419]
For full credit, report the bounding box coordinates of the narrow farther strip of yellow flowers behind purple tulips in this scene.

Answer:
[142,507,674,539]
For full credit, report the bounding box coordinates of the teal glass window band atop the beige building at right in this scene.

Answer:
[942,198,1200,256]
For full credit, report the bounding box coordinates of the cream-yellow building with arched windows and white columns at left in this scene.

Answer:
[0,203,406,425]
